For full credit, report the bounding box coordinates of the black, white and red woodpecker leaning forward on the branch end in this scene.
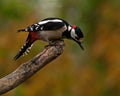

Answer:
[14,18,84,60]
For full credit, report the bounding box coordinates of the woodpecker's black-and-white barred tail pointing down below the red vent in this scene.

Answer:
[13,41,32,60]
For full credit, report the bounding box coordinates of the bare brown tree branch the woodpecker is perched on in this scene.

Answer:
[0,41,64,95]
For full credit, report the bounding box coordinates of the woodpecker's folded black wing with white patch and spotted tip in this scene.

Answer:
[18,18,67,32]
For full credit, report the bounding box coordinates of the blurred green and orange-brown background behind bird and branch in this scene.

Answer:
[0,0,120,96]
